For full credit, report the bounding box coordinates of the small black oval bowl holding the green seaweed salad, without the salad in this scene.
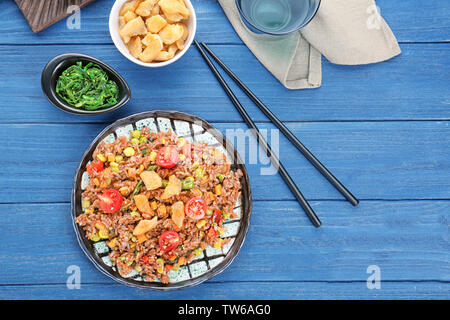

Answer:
[41,53,131,115]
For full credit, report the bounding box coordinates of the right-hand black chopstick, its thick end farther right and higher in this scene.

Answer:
[201,42,359,206]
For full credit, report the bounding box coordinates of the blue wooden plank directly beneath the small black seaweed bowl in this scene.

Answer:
[0,44,450,123]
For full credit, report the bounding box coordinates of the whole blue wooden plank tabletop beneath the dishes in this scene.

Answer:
[0,0,450,299]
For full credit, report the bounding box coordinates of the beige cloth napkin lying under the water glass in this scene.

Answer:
[219,0,401,89]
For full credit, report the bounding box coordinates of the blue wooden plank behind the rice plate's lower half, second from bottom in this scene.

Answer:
[0,201,450,284]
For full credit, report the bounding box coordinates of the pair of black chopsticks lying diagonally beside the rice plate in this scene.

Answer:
[194,40,359,227]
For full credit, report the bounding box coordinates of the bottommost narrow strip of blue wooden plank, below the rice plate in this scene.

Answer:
[0,282,444,300]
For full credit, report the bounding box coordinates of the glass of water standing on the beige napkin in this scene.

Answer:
[236,0,320,35]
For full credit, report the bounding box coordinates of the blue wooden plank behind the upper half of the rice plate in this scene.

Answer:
[0,121,450,203]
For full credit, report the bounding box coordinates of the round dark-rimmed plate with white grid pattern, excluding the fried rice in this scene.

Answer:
[71,111,252,291]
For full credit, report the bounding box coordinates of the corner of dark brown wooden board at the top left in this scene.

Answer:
[14,0,95,32]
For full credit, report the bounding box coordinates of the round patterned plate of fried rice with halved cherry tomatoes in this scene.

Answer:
[71,111,252,291]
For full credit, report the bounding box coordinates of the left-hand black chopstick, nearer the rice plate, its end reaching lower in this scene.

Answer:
[194,40,322,227]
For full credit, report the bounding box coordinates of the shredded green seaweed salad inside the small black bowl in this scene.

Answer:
[56,61,119,110]
